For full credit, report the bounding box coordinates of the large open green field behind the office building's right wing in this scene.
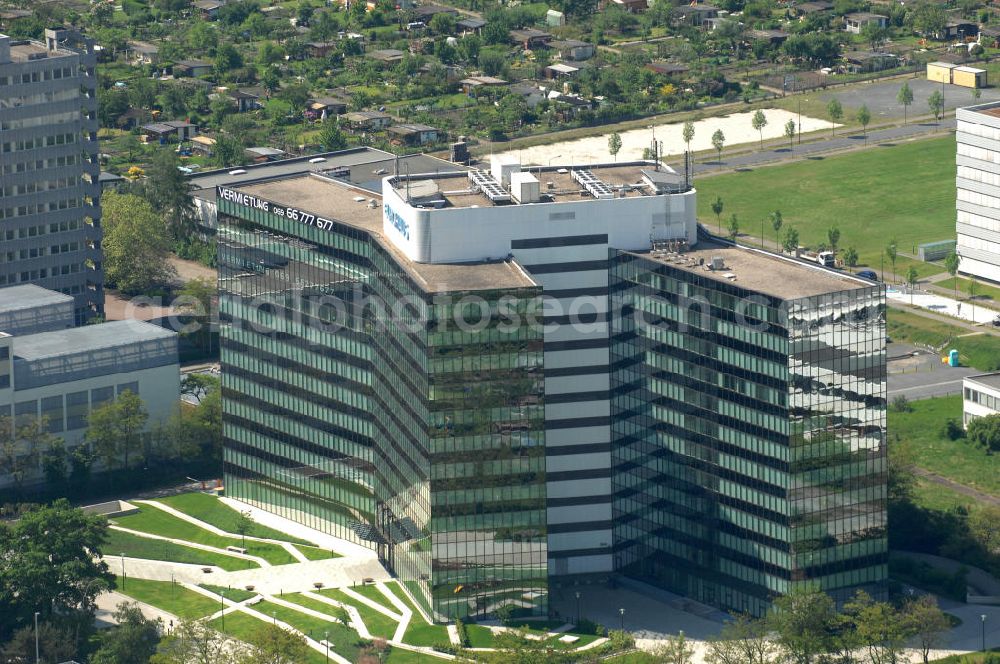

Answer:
[695,137,955,276]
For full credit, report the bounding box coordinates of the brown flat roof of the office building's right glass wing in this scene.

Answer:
[627,239,875,300]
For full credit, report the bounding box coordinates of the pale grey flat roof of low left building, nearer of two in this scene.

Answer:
[14,320,177,360]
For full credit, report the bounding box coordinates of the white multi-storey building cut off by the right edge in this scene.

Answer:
[955,102,1000,283]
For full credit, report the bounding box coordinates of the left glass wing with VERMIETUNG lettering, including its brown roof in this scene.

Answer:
[218,175,548,619]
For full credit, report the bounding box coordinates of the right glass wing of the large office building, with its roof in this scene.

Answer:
[610,243,888,615]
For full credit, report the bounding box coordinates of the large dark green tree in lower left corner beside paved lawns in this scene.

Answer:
[0,499,114,643]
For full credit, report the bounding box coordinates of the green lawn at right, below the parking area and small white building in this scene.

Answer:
[888,394,1000,496]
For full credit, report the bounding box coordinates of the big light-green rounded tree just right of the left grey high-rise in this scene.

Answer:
[101,191,176,295]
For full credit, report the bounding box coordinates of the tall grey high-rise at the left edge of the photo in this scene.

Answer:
[0,29,104,324]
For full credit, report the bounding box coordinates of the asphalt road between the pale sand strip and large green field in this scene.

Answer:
[688,118,955,175]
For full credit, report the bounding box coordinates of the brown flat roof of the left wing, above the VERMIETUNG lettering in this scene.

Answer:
[239,174,537,293]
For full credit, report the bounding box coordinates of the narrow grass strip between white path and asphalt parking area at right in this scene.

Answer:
[885,307,1000,371]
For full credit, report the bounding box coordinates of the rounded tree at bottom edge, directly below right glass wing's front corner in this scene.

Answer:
[767,587,838,664]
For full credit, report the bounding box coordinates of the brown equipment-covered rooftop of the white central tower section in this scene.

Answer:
[392,158,674,207]
